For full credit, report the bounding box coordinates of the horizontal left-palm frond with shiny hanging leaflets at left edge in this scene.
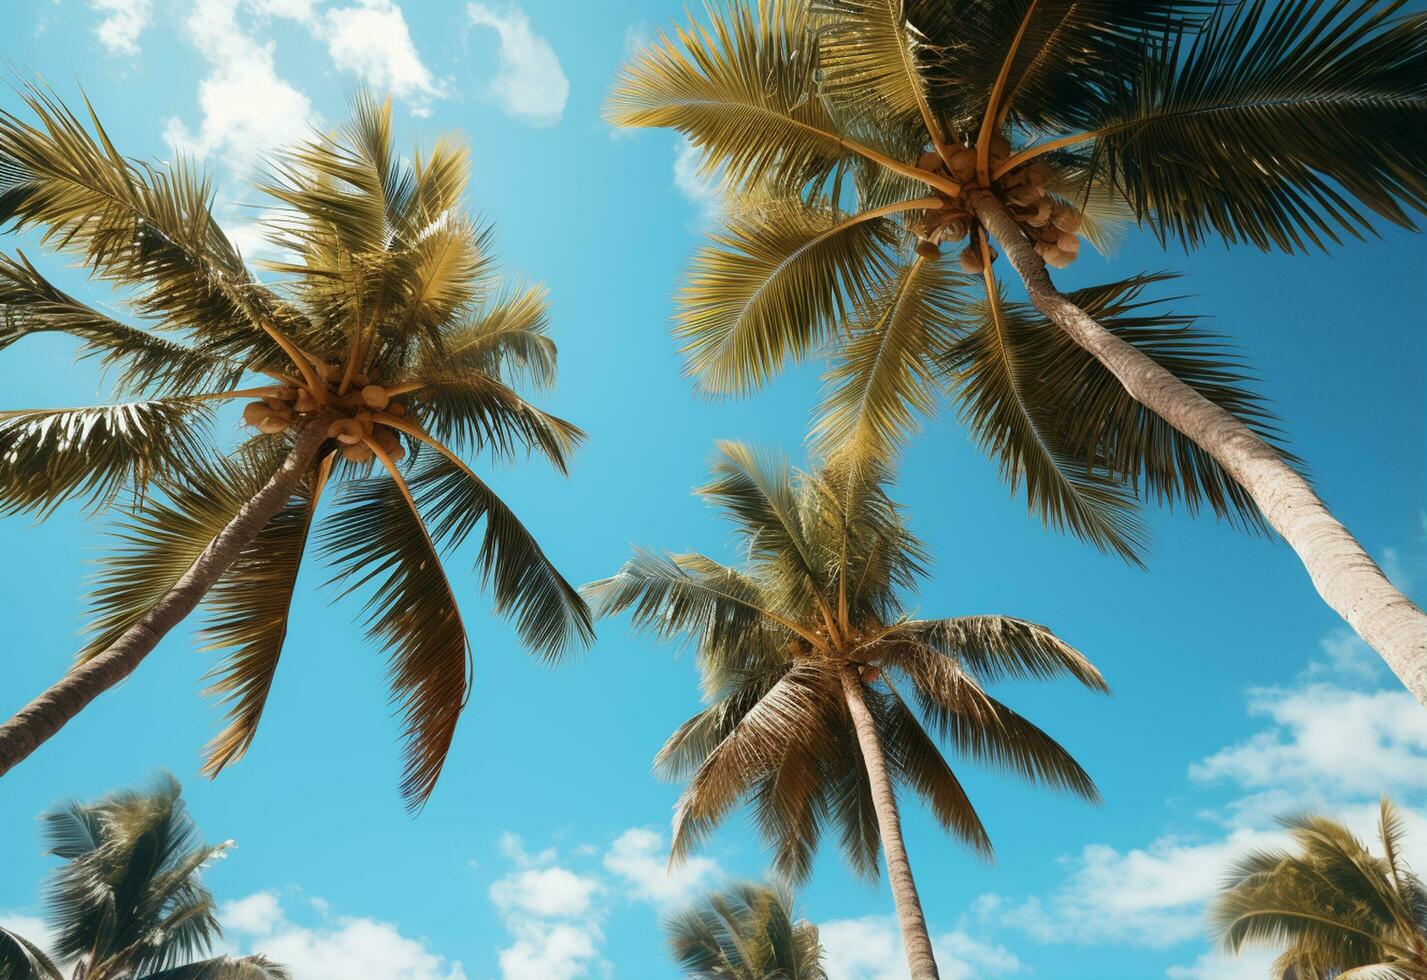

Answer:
[0,398,210,516]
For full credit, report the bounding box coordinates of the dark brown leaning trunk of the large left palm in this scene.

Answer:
[0,419,327,776]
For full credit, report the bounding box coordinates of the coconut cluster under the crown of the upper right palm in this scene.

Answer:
[912,136,1083,275]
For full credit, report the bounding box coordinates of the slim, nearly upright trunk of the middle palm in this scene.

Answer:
[842,670,940,980]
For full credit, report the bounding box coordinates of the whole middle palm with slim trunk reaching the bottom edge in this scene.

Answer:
[585,442,1107,979]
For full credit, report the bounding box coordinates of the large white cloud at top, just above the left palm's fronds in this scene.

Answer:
[166,0,320,175]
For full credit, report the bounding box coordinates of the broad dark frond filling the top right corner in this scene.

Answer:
[1085,0,1427,251]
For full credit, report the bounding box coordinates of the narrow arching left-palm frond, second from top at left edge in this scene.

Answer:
[0,254,244,394]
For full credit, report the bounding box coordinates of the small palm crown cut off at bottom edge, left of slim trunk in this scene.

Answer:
[664,882,828,980]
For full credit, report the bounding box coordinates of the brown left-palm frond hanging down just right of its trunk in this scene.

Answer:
[196,464,330,776]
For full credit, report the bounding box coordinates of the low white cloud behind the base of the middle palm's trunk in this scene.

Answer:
[818,916,1022,980]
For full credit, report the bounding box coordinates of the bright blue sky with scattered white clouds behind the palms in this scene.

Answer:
[0,0,1427,980]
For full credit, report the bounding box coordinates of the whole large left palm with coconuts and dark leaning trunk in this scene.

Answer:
[0,88,591,805]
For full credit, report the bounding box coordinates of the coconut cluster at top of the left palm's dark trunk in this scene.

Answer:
[243,362,407,462]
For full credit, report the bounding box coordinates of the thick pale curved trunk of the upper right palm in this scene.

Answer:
[968,190,1427,705]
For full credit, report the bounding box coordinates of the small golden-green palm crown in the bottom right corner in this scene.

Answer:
[1210,797,1427,980]
